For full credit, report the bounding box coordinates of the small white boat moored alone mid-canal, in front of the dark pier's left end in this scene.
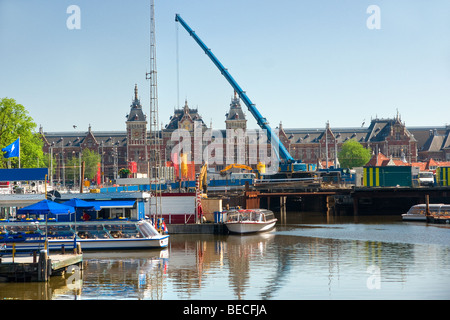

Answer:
[225,209,277,234]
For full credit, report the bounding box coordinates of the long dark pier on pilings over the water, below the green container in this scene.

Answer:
[236,186,450,216]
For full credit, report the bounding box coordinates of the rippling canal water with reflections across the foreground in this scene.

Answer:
[0,212,450,300]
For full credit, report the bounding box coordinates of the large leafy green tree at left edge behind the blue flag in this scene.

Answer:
[0,98,44,168]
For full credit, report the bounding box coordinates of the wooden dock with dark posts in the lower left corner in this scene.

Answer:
[0,246,83,282]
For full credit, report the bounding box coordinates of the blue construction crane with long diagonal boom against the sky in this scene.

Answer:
[175,14,307,172]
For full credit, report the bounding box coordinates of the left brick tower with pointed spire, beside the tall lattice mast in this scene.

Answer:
[126,85,148,173]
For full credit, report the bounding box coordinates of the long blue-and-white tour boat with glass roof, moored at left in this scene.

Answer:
[0,220,169,252]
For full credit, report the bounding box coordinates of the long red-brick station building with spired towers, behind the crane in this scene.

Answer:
[40,86,450,183]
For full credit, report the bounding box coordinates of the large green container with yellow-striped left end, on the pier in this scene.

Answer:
[363,166,418,187]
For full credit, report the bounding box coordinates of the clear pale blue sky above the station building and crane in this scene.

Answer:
[0,0,450,131]
